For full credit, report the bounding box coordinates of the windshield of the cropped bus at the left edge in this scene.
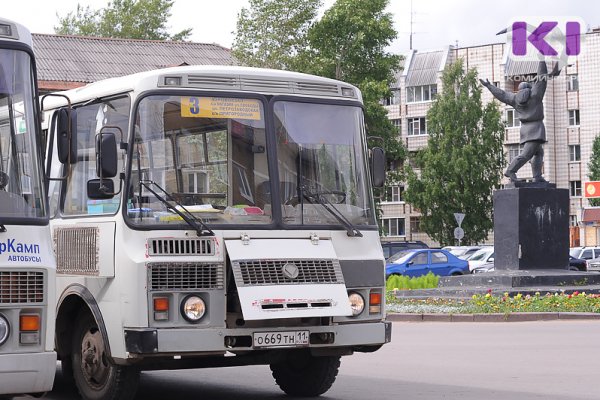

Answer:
[0,49,46,224]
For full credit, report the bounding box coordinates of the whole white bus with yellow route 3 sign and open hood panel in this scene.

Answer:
[44,66,391,400]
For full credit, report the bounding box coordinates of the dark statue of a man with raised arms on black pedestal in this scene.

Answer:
[479,61,560,183]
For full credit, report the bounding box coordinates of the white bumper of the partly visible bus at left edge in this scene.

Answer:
[0,351,56,395]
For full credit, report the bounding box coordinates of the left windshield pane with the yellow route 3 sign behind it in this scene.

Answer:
[127,95,271,225]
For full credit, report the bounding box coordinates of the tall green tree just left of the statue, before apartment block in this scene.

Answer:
[405,60,504,245]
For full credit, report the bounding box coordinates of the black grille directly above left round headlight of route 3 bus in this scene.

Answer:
[148,262,224,291]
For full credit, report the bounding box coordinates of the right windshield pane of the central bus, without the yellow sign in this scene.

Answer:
[274,101,374,225]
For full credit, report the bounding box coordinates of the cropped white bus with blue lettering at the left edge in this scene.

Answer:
[0,18,56,396]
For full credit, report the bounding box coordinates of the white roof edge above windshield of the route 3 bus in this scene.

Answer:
[46,65,362,108]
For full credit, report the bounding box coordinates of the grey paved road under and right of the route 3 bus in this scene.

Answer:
[21,321,600,400]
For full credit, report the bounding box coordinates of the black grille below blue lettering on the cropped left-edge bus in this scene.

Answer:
[0,271,44,304]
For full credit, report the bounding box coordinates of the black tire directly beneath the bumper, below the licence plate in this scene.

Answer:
[271,351,340,397]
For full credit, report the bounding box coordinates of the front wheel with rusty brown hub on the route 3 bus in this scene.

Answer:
[71,313,139,400]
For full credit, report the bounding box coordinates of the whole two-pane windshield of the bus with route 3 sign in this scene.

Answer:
[127,95,374,228]
